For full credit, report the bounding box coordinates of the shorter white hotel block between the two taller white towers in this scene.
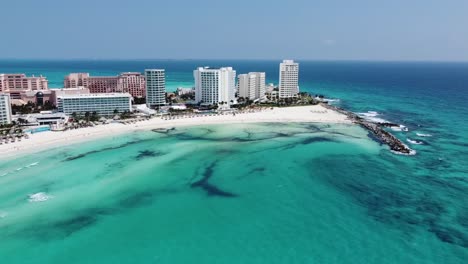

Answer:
[237,72,265,100]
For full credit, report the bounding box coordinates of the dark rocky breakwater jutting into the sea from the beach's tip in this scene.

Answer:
[322,103,416,155]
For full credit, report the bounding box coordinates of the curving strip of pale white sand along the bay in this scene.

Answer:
[0,105,352,159]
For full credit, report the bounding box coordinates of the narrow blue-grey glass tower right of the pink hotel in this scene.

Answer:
[145,69,166,108]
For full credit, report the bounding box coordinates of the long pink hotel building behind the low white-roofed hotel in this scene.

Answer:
[63,72,146,97]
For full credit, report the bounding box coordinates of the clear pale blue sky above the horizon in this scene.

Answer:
[0,0,468,61]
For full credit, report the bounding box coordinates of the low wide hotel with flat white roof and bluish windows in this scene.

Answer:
[57,93,132,116]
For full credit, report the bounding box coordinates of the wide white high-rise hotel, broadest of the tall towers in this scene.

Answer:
[193,67,236,106]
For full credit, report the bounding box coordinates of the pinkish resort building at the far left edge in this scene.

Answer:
[0,73,49,100]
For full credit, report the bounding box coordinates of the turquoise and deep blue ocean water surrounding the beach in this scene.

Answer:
[0,61,468,263]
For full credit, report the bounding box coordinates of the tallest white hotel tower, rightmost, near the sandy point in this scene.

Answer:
[279,60,299,98]
